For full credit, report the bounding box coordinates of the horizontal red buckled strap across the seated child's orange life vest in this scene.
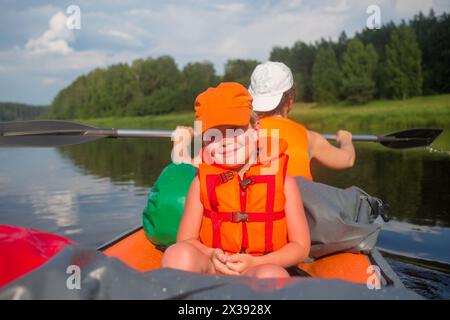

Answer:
[203,210,285,223]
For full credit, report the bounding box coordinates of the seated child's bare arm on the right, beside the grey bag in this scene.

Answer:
[254,175,311,267]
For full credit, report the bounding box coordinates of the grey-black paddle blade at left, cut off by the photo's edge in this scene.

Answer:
[0,120,104,147]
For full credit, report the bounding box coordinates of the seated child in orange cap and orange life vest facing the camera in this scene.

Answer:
[162,83,310,278]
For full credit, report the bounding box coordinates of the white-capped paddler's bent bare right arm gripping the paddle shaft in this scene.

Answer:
[308,130,356,169]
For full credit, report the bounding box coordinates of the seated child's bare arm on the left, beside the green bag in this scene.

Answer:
[177,177,214,257]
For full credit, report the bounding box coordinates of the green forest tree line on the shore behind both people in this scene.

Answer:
[49,10,450,119]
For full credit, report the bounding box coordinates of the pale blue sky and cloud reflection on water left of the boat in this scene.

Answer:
[0,148,148,246]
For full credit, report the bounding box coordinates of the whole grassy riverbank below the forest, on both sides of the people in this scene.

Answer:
[83,94,450,133]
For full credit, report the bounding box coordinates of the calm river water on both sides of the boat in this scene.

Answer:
[0,139,450,299]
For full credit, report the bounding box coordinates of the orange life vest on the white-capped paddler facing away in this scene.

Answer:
[259,116,313,180]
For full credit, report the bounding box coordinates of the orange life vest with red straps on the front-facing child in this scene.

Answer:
[198,139,288,255]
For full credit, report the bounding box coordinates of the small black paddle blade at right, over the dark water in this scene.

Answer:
[379,128,442,149]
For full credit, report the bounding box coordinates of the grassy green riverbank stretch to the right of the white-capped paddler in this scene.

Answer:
[290,94,450,134]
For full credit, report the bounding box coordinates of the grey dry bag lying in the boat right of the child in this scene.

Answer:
[296,177,388,259]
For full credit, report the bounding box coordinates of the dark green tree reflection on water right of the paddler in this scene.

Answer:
[312,145,450,227]
